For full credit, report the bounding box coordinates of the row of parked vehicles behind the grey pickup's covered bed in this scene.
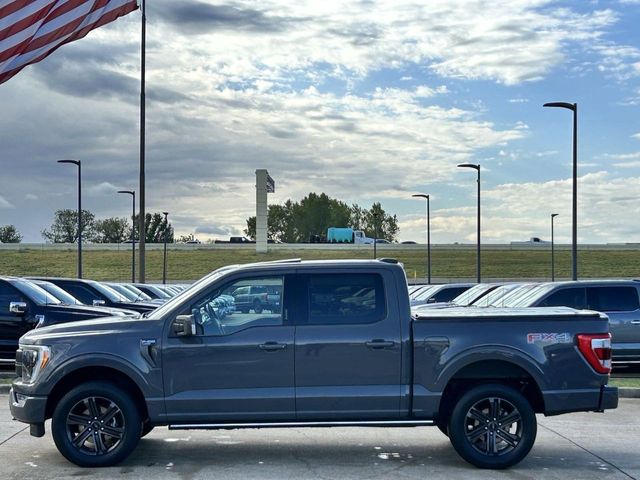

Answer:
[409,280,640,367]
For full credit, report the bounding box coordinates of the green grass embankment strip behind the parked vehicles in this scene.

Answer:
[0,248,640,282]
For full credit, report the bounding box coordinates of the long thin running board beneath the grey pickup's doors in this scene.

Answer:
[169,420,434,430]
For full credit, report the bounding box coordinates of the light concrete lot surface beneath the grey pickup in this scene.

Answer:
[0,395,640,480]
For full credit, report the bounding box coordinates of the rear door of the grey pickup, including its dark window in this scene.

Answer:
[295,269,402,420]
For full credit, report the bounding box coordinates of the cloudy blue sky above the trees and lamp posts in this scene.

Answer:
[0,0,640,243]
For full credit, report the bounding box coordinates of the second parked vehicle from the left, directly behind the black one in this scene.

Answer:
[30,277,158,313]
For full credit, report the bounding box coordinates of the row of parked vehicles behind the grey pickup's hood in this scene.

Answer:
[0,276,187,368]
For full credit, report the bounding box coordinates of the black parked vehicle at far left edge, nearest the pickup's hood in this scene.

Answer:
[0,277,131,367]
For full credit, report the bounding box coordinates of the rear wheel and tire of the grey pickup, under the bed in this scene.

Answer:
[448,384,537,469]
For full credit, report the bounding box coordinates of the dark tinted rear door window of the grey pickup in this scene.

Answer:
[308,274,386,325]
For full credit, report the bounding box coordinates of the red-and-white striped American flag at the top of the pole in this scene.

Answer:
[0,0,138,83]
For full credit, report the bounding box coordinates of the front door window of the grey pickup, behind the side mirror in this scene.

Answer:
[190,277,284,336]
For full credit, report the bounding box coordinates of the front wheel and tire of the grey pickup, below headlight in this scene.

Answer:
[51,381,142,467]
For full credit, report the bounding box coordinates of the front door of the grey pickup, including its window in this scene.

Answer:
[163,276,295,423]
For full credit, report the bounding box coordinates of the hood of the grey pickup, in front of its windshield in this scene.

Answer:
[20,317,156,345]
